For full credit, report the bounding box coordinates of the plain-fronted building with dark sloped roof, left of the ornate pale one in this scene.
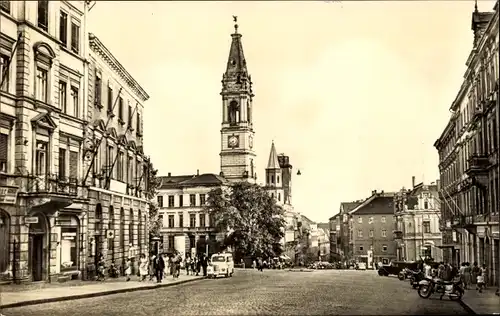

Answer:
[346,191,396,266]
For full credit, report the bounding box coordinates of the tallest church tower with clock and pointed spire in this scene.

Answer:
[220,17,257,183]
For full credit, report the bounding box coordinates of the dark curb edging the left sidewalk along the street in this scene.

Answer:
[0,277,206,311]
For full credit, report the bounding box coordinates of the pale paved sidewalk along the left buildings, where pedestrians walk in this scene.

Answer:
[0,275,204,311]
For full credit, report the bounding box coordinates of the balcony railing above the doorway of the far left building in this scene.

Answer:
[25,174,78,196]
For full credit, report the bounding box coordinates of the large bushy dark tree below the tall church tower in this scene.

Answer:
[205,182,285,260]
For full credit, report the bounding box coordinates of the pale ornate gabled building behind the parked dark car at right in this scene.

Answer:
[394,177,443,262]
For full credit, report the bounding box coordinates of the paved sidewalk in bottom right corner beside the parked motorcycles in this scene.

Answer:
[460,287,500,315]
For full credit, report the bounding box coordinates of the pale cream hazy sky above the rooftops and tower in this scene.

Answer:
[88,1,494,221]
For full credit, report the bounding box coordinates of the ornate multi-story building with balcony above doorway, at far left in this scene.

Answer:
[0,0,147,281]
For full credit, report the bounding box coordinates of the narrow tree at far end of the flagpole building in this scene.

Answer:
[144,158,161,238]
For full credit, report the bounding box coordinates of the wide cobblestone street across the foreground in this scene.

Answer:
[2,270,467,316]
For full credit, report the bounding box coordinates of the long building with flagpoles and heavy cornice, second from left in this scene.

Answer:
[84,34,151,271]
